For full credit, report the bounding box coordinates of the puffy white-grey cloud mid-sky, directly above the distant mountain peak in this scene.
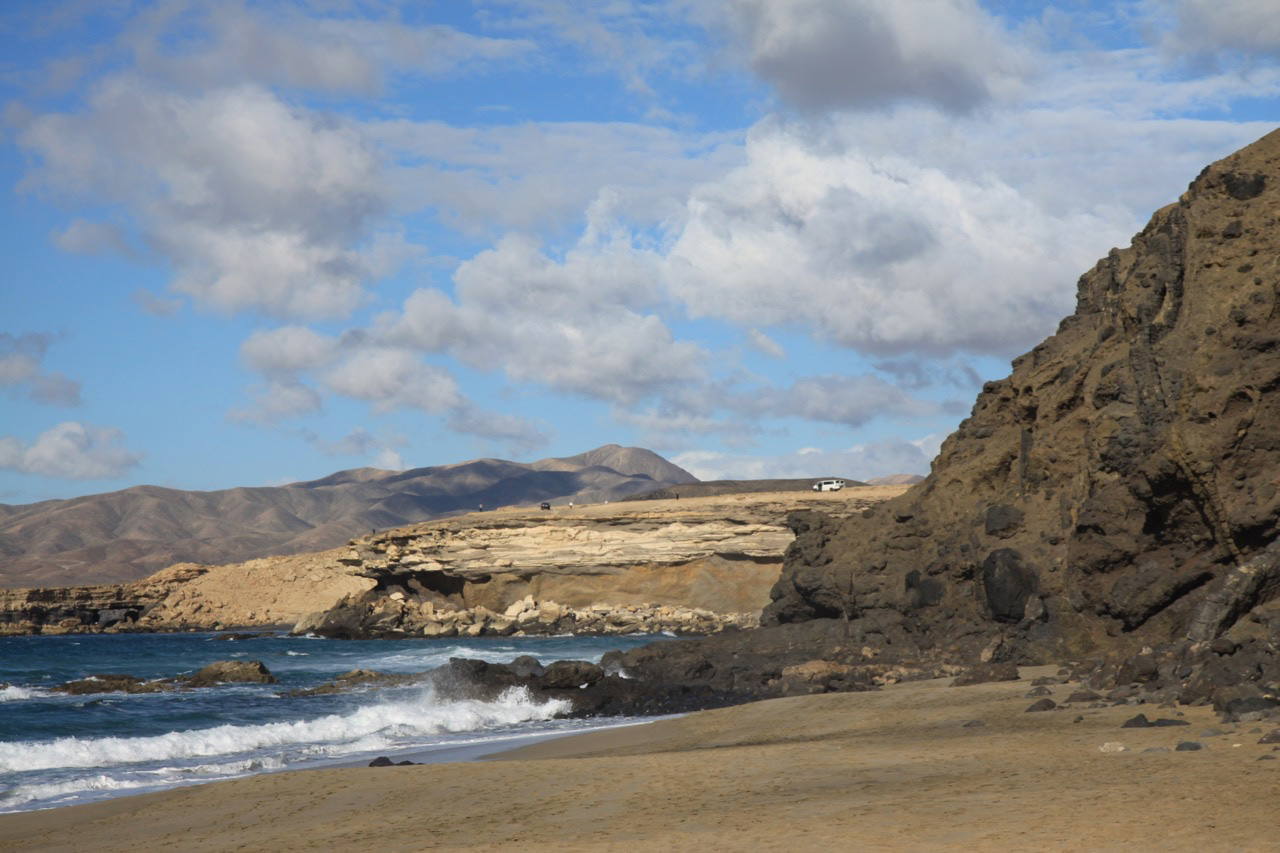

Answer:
[385,233,707,403]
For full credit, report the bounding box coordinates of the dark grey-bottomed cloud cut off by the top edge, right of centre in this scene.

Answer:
[726,0,1024,111]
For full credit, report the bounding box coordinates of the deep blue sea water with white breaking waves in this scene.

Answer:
[0,634,655,813]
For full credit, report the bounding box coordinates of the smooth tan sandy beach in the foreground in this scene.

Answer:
[0,667,1280,852]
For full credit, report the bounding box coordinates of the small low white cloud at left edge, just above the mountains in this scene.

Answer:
[0,421,142,480]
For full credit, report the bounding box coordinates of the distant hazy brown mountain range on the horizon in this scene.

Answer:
[0,444,698,588]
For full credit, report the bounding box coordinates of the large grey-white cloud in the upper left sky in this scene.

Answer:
[19,80,383,318]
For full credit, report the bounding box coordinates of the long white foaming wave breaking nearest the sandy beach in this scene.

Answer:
[0,689,570,772]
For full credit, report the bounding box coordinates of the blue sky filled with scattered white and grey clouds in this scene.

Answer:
[0,0,1280,503]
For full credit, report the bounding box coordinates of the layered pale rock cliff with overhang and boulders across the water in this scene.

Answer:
[294,487,902,637]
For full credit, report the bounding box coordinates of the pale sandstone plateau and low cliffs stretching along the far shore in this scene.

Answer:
[0,485,909,637]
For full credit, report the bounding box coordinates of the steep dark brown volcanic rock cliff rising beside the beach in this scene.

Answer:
[765,132,1280,661]
